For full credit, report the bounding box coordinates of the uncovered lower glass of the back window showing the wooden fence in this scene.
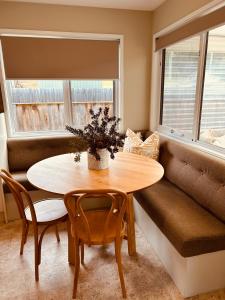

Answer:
[6,80,117,134]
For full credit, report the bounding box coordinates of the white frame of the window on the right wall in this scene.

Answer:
[149,0,225,159]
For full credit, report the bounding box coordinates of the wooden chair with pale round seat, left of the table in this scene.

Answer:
[0,169,68,281]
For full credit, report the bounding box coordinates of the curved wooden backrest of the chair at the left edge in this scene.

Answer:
[0,169,37,222]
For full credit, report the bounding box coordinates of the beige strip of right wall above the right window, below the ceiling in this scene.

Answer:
[152,0,218,33]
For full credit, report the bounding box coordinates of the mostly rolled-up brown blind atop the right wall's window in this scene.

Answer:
[155,6,225,51]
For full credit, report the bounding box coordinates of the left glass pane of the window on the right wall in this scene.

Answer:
[161,36,200,134]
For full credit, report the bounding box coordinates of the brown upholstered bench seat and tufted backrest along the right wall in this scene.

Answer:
[135,138,225,257]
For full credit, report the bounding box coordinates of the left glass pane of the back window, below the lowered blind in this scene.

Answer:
[6,80,65,133]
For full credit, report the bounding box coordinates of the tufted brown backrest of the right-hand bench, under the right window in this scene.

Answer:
[159,137,225,222]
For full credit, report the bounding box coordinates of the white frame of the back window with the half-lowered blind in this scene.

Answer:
[0,28,124,138]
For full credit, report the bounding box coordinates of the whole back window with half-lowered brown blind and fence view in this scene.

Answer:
[0,33,122,136]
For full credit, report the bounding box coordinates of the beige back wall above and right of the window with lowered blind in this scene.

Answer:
[0,1,151,129]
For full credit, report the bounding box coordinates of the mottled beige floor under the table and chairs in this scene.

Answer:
[0,221,225,300]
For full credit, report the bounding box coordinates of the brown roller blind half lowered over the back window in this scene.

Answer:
[1,36,119,79]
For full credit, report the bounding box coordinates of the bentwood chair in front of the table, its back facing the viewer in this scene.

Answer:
[64,190,127,298]
